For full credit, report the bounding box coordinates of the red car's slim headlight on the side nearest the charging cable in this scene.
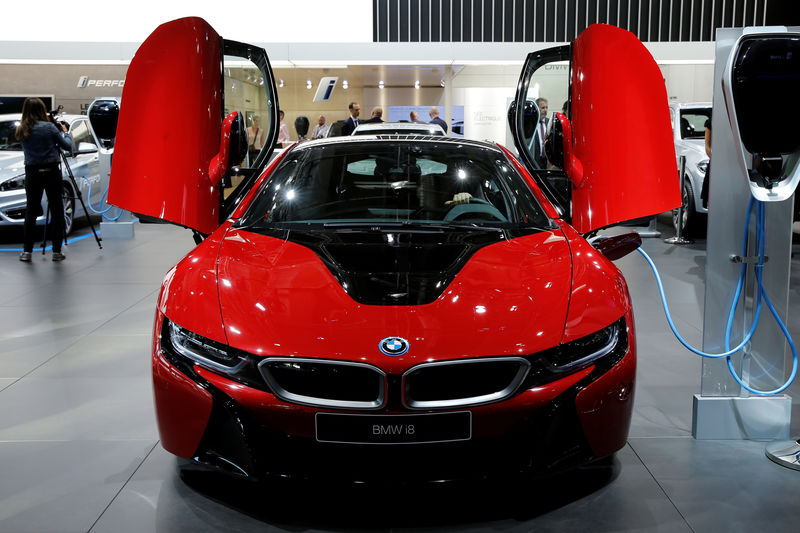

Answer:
[542,318,627,373]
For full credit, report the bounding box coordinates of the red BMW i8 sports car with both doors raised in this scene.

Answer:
[109,18,680,481]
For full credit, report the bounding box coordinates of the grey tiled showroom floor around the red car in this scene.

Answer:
[0,220,800,533]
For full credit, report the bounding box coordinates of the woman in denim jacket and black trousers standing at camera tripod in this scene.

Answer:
[15,98,72,262]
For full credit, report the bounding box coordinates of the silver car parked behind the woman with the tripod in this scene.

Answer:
[0,114,108,233]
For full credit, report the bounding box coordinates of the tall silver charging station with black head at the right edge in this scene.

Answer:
[692,27,800,439]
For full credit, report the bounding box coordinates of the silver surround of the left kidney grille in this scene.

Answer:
[258,357,387,410]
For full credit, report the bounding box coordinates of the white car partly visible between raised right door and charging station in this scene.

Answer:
[669,102,711,235]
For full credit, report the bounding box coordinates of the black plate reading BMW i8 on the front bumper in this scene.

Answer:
[316,411,472,444]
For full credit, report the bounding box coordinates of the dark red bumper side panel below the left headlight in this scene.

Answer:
[153,308,213,458]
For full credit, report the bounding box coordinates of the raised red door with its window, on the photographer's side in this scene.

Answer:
[108,17,278,234]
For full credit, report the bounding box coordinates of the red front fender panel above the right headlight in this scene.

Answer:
[558,221,631,342]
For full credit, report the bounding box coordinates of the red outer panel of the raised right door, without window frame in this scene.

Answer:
[570,24,681,234]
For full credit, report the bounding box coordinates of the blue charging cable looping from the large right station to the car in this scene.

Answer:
[637,197,798,396]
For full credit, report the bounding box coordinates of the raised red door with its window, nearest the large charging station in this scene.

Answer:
[509,24,681,234]
